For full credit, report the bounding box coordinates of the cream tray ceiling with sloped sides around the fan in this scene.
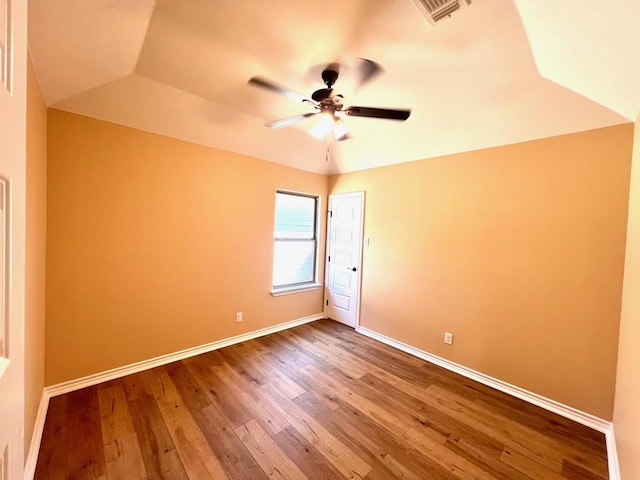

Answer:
[29,0,640,173]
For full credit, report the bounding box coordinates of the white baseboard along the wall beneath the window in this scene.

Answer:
[45,313,324,397]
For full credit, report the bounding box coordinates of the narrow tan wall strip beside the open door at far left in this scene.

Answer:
[24,58,47,456]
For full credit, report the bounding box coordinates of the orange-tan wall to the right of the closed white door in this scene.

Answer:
[331,124,633,420]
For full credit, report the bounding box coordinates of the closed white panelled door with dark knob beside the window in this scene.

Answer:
[325,192,364,328]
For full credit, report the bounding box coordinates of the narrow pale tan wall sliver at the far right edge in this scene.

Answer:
[613,115,640,480]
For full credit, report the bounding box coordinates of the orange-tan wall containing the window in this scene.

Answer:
[46,110,328,385]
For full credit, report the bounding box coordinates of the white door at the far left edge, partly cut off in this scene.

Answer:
[0,0,27,480]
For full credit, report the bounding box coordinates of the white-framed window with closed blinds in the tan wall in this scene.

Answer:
[272,191,318,294]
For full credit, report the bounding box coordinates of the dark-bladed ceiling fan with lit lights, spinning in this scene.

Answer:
[249,58,411,141]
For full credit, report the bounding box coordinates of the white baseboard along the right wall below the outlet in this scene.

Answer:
[356,327,613,434]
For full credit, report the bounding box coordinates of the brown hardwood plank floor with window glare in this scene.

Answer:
[35,320,608,480]
